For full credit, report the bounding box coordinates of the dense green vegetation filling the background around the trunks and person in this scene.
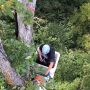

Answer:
[0,0,90,90]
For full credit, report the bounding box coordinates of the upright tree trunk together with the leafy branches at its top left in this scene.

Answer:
[0,0,36,44]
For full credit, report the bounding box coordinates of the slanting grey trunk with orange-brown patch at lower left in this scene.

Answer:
[0,39,24,86]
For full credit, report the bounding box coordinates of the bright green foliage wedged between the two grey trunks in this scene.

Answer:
[4,39,35,75]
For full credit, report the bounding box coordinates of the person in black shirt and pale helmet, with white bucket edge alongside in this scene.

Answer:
[36,44,60,78]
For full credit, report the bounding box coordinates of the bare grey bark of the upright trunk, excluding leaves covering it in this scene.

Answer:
[17,0,36,44]
